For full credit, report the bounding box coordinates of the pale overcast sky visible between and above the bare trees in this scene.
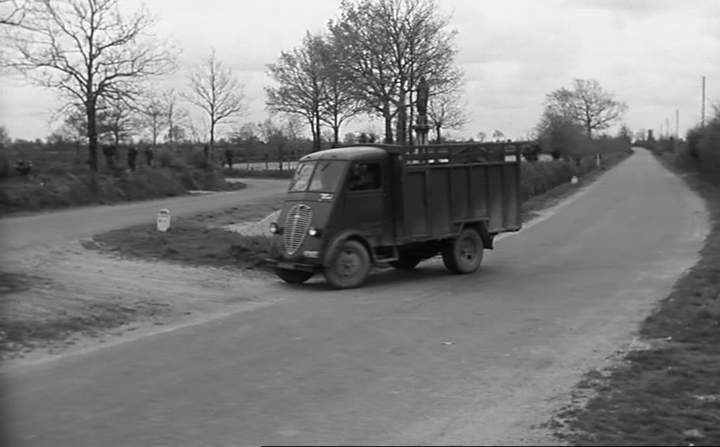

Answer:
[0,0,720,139]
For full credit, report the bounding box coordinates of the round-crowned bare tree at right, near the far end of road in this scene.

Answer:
[545,79,627,138]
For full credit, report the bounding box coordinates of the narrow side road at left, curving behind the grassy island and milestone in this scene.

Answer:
[0,179,288,253]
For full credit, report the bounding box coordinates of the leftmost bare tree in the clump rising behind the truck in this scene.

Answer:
[265,32,327,150]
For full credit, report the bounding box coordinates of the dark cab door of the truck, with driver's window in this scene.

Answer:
[343,160,393,245]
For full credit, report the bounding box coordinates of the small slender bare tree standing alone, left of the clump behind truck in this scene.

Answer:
[183,49,245,151]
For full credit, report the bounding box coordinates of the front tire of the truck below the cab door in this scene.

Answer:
[325,240,370,289]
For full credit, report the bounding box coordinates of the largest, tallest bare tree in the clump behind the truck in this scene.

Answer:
[329,0,460,143]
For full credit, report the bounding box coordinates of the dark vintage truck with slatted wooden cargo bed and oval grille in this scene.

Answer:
[269,142,523,288]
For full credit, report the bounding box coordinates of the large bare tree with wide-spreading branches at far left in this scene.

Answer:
[2,0,175,171]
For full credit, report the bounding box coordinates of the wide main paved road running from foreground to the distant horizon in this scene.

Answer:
[2,151,707,446]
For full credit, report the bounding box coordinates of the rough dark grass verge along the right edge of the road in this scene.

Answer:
[552,153,720,445]
